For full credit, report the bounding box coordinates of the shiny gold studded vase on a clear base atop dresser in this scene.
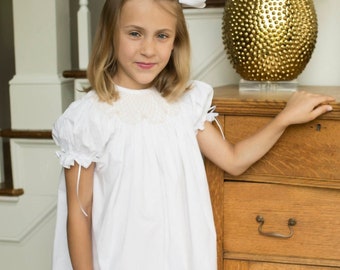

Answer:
[222,0,318,82]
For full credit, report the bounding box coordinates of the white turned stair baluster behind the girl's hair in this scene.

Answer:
[77,0,91,70]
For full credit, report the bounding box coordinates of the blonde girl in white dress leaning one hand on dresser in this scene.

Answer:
[53,0,333,270]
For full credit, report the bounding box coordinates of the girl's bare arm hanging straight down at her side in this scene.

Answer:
[65,163,95,270]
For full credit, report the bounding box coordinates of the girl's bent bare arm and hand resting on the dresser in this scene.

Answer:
[197,91,334,175]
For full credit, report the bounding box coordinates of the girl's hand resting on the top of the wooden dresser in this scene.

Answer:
[277,91,335,126]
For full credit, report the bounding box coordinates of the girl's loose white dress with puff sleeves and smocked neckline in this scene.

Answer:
[53,81,217,270]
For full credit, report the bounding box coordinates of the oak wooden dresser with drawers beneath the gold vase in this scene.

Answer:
[206,86,340,270]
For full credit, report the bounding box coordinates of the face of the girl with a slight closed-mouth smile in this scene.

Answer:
[114,0,176,89]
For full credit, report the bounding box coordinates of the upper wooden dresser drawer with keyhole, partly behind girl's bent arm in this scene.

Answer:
[225,116,340,187]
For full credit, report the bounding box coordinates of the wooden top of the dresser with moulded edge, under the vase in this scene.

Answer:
[213,85,340,120]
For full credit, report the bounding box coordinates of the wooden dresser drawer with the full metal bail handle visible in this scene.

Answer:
[223,181,340,266]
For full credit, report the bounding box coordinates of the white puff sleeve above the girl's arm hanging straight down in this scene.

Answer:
[52,92,109,168]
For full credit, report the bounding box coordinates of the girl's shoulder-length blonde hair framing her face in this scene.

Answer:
[87,0,190,102]
